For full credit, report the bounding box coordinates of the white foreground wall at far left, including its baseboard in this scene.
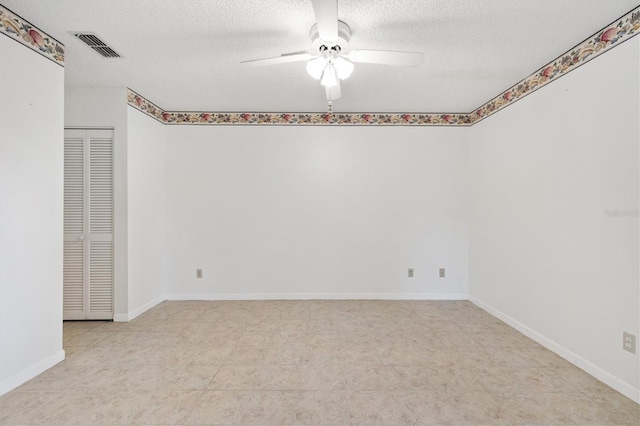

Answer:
[0,36,64,394]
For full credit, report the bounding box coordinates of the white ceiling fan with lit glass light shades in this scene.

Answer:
[242,0,424,111]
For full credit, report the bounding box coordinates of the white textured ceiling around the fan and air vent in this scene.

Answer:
[5,0,639,112]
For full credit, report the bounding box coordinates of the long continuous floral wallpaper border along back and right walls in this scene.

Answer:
[127,6,640,126]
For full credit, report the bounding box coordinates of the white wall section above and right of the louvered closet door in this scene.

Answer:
[64,87,129,318]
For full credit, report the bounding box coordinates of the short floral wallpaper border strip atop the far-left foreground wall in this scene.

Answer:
[0,4,64,67]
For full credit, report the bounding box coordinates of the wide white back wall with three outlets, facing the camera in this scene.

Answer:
[166,126,469,298]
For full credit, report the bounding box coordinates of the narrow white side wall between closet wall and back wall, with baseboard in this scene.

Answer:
[127,108,167,319]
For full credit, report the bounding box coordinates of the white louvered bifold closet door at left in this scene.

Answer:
[63,129,113,319]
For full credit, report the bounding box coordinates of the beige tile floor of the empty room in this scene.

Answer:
[0,301,640,426]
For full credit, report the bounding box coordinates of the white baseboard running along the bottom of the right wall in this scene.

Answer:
[469,296,640,404]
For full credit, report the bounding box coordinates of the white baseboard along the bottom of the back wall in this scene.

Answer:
[165,293,467,300]
